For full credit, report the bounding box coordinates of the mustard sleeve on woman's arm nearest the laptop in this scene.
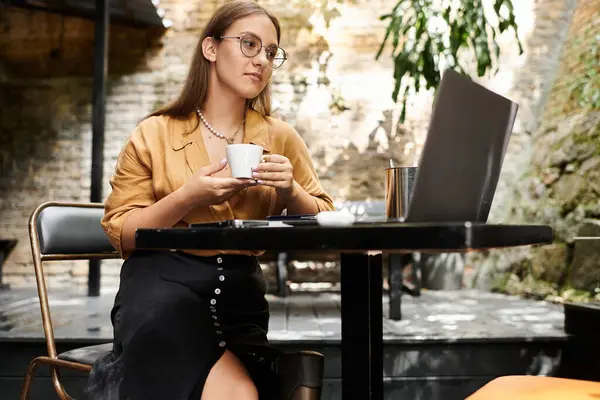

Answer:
[284,128,334,211]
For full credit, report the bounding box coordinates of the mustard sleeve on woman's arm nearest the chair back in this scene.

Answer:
[101,127,156,258]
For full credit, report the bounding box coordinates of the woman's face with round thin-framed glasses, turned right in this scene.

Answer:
[215,15,278,99]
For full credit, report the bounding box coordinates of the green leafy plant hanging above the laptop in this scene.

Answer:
[375,0,523,121]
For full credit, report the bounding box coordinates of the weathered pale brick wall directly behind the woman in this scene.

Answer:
[0,0,575,286]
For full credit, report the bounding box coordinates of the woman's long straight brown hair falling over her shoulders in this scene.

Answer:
[144,0,281,125]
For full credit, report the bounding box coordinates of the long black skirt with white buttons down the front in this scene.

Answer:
[86,251,279,400]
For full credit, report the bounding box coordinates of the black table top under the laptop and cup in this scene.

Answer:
[136,222,553,252]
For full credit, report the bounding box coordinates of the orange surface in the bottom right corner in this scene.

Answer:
[467,376,600,400]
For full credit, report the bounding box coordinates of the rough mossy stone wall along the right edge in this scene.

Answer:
[478,0,600,304]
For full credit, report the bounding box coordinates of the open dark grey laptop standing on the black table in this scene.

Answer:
[405,70,518,223]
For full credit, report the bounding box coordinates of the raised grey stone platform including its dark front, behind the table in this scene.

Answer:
[0,289,568,400]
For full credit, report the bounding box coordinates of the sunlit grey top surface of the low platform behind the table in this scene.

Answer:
[0,289,565,342]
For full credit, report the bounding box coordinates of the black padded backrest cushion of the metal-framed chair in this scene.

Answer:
[37,206,115,255]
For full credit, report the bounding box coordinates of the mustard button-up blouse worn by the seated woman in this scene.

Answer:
[102,110,334,258]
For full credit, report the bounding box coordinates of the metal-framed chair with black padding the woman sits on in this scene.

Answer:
[21,202,324,400]
